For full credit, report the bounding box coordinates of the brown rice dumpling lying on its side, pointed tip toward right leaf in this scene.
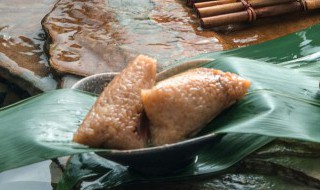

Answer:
[141,68,250,146]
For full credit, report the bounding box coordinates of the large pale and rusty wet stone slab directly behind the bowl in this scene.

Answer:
[44,0,222,75]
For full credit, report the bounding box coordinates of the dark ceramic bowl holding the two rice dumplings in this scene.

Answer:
[72,60,221,174]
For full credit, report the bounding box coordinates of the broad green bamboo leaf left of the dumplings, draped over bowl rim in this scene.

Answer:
[0,90,96,172]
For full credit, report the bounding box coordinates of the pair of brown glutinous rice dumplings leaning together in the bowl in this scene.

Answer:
[73,55,250,149]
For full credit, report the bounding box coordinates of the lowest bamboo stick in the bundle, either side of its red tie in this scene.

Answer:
[200,0,302,28]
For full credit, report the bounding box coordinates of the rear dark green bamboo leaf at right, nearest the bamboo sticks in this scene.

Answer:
[191,24,320,79]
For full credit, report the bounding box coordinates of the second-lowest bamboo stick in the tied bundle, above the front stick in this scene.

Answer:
[196,0,296,18]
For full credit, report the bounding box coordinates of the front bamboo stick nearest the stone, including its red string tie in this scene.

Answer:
[200,0,320,28]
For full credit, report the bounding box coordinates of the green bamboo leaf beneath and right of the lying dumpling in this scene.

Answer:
[201,57,320,142]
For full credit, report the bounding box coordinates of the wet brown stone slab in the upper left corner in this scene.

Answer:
[0,0,57,94]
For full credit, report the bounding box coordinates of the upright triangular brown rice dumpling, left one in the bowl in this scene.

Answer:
[73,55,156,149]
